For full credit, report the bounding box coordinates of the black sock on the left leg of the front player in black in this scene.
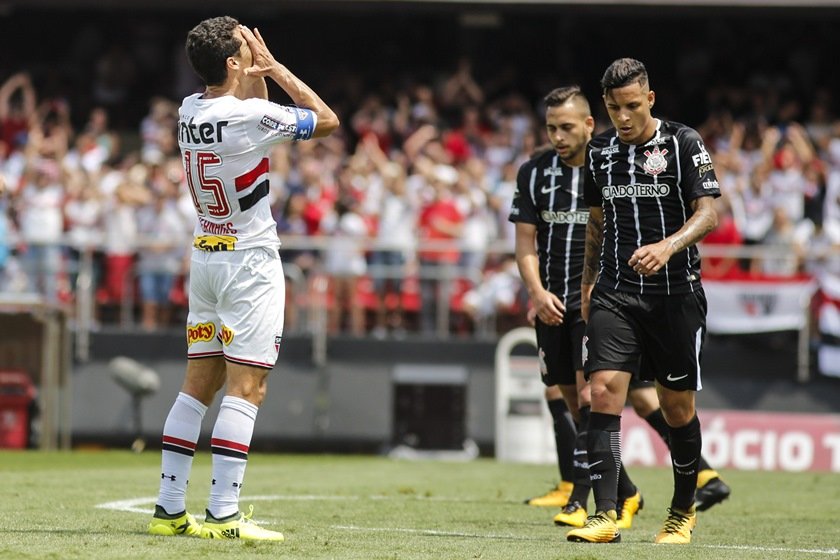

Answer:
[586,412,621,511]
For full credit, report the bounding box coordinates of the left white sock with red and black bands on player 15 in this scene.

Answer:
[157,393,207,514]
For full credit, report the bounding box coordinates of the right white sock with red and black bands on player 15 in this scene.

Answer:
[207,396,258,518]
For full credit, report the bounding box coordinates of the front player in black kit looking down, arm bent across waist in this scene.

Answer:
[567,58,720,544]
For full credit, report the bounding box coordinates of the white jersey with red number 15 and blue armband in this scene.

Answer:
[178,94,317,251]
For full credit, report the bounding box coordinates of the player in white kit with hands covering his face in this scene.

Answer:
[148,16,339,541]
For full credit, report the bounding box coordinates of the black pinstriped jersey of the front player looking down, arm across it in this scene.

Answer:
[584,120,720,295]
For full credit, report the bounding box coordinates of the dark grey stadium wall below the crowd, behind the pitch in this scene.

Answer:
[71,333,840,454]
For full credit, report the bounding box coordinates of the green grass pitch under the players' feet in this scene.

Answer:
[0,451,840,560]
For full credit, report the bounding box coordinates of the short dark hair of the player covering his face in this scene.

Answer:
[186,16,242,86]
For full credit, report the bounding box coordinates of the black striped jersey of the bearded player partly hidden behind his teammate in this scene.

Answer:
[508,150,589,309]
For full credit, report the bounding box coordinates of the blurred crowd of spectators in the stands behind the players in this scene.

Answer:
[0,59,840,337]
